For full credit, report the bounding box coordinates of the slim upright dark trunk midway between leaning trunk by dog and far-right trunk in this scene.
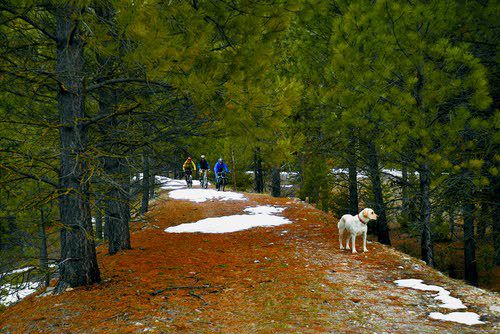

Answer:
[420,164,434,267]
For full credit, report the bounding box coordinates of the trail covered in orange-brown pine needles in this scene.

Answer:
[0,190,500,333]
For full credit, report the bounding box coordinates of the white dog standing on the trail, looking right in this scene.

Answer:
[338,208,378,253]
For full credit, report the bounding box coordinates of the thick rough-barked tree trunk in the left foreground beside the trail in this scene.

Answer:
[56,3,100,292]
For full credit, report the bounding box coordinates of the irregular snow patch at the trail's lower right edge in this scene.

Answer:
[394,278,484,325]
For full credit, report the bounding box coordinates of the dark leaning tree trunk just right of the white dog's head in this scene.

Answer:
[367,141,391,245]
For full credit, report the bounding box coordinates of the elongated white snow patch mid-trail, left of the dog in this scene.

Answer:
[165,205,291,233]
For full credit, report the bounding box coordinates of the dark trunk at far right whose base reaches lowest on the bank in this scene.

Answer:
[463,200,478,286]
